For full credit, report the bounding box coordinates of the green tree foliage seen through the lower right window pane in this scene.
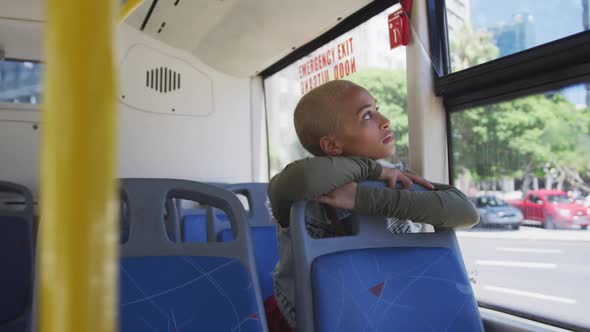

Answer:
[452,94,590,181]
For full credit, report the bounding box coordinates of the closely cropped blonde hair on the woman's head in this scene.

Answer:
[293,80,360,156]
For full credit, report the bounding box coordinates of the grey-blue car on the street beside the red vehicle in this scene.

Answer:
[472,195,524,229]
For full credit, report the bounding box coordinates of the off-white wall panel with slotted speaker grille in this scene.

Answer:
[119,44,214,116]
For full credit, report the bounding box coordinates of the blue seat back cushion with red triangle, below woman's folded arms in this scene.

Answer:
[311,247,483,332]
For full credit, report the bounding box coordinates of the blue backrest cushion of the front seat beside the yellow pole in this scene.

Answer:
[119,256,262,332]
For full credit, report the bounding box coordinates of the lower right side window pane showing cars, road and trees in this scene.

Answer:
[450,84,590,328]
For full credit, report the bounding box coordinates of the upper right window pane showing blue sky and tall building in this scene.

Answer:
[445,0,590,72]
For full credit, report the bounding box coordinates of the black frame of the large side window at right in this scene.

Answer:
[427,0,590,330]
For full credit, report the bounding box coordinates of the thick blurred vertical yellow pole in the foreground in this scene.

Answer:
[37,0,118,332]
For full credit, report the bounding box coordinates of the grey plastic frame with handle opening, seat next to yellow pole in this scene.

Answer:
[120,178,267,331]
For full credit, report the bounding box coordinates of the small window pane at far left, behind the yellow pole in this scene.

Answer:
[0,61,42,104]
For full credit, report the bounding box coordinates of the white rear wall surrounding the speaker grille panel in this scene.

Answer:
[117,24,252,182]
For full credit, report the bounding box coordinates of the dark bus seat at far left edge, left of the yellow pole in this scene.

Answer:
[0,181,34,332]
